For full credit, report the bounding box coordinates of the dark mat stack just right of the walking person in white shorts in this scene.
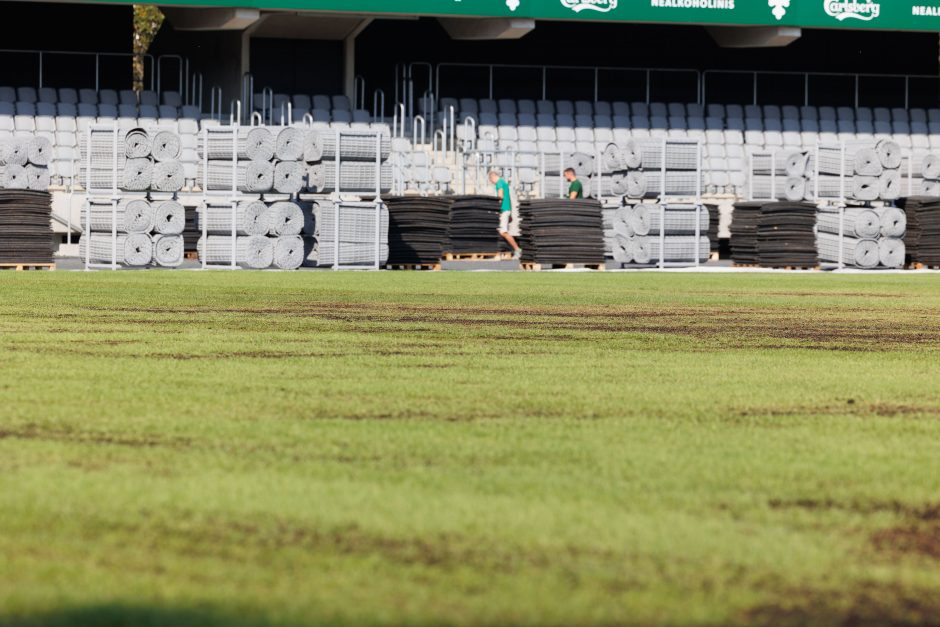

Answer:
[519,199,604,264]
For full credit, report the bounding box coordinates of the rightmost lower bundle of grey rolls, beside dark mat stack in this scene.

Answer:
[816,207,907,269]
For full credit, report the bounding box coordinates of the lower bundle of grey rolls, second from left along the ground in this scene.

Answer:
[196,200,311,270]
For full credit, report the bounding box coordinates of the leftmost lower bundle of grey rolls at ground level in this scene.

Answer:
[79,197,186,268]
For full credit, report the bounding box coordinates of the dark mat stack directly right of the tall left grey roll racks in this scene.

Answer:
[385,196,451,264]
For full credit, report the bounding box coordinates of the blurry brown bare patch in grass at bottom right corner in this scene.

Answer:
[740,582,940,627]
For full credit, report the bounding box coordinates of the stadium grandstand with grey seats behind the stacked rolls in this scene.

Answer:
[0,0,940,254]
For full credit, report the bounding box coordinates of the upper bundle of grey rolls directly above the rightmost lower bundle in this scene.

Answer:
[816,139,903,202]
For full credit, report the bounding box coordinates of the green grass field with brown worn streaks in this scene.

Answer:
[0,272,940,627]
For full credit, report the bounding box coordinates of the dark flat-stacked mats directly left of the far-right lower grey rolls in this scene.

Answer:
[757,202,819,268]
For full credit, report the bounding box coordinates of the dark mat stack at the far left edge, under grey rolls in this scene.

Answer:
[0,189,53,263]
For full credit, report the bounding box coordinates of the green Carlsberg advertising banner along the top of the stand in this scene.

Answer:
[121,0,940,31]
